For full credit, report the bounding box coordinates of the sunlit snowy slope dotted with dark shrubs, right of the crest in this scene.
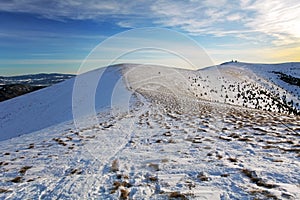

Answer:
[125,62,300,115]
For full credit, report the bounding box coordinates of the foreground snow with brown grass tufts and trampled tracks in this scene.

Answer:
[0,94,300,199]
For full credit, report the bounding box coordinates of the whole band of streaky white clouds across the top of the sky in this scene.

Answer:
[0,0,300,45]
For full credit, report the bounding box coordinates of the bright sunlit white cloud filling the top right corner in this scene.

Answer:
[242,0,300,45]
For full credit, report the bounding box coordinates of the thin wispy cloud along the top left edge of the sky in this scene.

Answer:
[0,0,147,20]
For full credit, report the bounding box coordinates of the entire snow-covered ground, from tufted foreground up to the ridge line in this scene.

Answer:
[0,63,300,199]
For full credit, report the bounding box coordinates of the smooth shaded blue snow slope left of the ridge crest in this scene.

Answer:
[0,66,129,140]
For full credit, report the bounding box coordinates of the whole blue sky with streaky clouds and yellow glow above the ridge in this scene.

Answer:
[0,0,300,75]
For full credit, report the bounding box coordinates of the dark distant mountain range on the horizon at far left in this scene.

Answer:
[0,73,75,101]
